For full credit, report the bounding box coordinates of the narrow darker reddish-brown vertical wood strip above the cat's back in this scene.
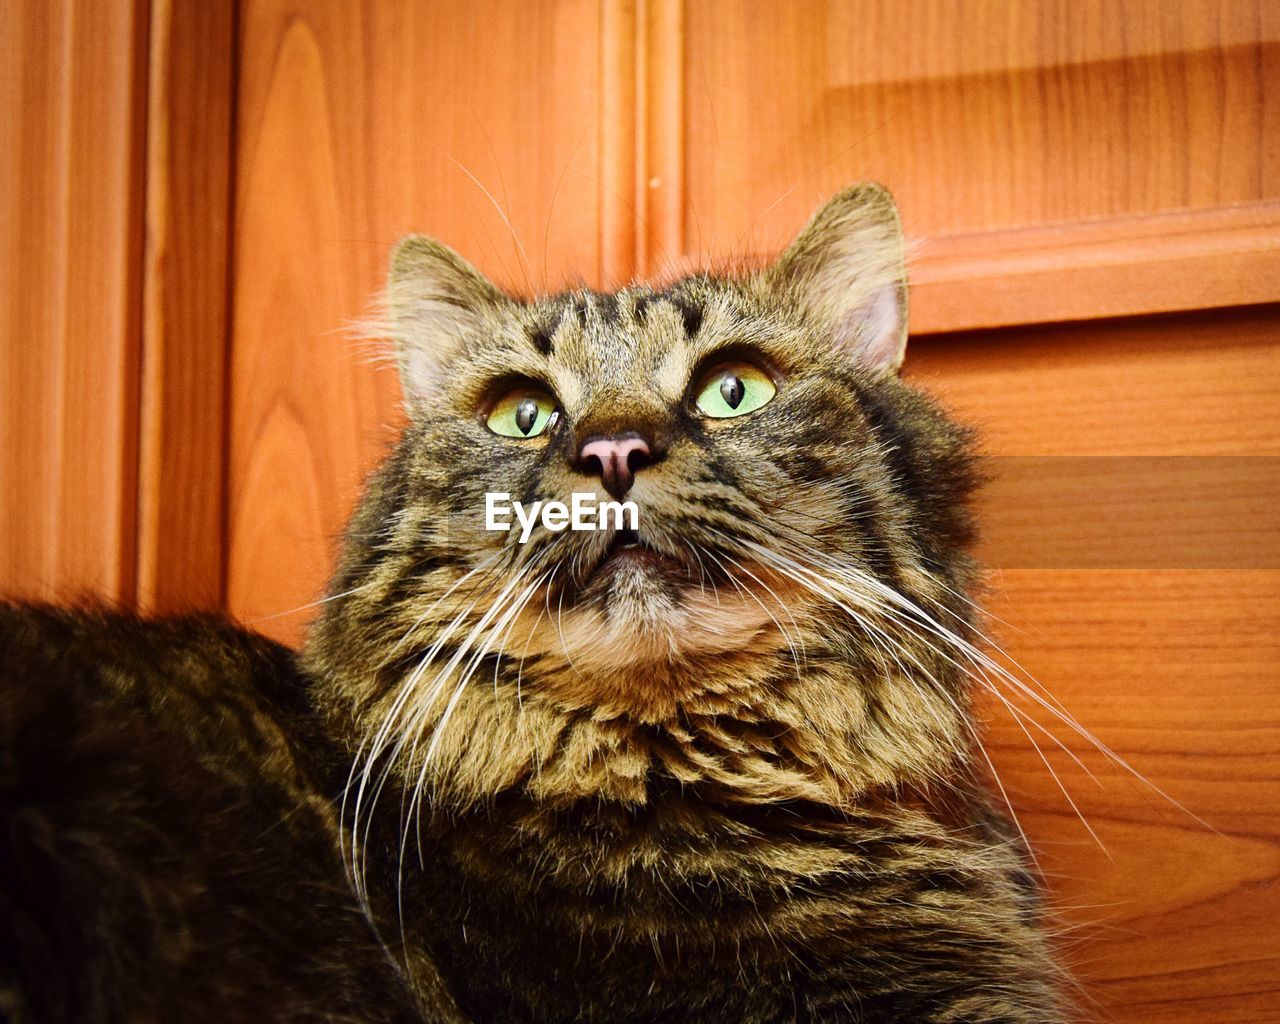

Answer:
[137,0,236,614]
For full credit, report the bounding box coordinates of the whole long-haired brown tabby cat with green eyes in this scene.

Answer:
[0,186,1066,1024]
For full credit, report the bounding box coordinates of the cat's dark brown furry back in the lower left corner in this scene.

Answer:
[0,605,430,1021]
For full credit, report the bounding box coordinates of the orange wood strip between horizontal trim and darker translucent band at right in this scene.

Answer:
[908,306,1280,457]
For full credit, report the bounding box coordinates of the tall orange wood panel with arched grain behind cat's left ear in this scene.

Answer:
[227,0,616,639]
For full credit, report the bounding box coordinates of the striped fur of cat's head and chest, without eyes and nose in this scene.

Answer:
[312,187,1065,1021]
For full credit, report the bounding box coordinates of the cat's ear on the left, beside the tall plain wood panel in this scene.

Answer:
[385,234,509,410]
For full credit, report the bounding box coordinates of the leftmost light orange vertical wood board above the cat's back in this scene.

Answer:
[0,0,146,604]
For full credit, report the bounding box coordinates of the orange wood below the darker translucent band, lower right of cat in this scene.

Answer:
[988,570,1280,1024]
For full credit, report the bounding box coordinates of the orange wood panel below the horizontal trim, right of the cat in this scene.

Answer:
[908,307,1280,1024]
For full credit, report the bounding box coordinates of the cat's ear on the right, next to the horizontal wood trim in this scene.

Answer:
[764,183,906,370]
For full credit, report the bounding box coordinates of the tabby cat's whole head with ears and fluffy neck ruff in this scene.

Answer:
[308,186,970,804]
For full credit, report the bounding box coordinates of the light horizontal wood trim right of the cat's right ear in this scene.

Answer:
[911,201,1280,334]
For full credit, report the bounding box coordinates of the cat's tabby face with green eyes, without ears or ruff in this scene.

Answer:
[391,271,878,672]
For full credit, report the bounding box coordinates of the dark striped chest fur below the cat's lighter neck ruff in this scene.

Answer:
[373,788,1039,1021]
